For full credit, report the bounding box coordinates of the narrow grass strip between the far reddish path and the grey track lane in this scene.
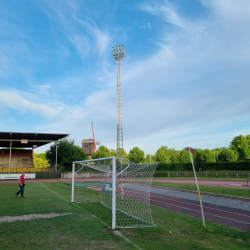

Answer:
[152,180,250,199]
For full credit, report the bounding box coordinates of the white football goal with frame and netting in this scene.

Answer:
[71,157,157,229]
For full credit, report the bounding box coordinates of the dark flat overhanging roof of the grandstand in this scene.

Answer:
[0,132,69,148]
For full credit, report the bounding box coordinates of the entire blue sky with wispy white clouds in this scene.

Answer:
[0,0,250,154]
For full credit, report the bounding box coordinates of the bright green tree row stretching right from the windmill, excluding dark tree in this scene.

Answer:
[92,135,250,163]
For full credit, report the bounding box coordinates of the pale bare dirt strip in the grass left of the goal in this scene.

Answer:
[0,213,72,223]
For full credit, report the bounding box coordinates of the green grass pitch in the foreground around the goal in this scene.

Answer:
[0,182,250,250]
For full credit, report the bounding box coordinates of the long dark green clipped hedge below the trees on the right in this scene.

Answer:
[156,161,250,171]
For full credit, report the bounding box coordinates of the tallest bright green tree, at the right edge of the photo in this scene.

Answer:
[230,135,250,161]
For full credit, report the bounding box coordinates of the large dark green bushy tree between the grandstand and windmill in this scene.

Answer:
[46,138,87,170]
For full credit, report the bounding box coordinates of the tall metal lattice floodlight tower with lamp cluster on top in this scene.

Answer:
[112,45,126,157]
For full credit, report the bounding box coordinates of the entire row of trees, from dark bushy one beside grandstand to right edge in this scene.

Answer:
[45,135,250,169]
